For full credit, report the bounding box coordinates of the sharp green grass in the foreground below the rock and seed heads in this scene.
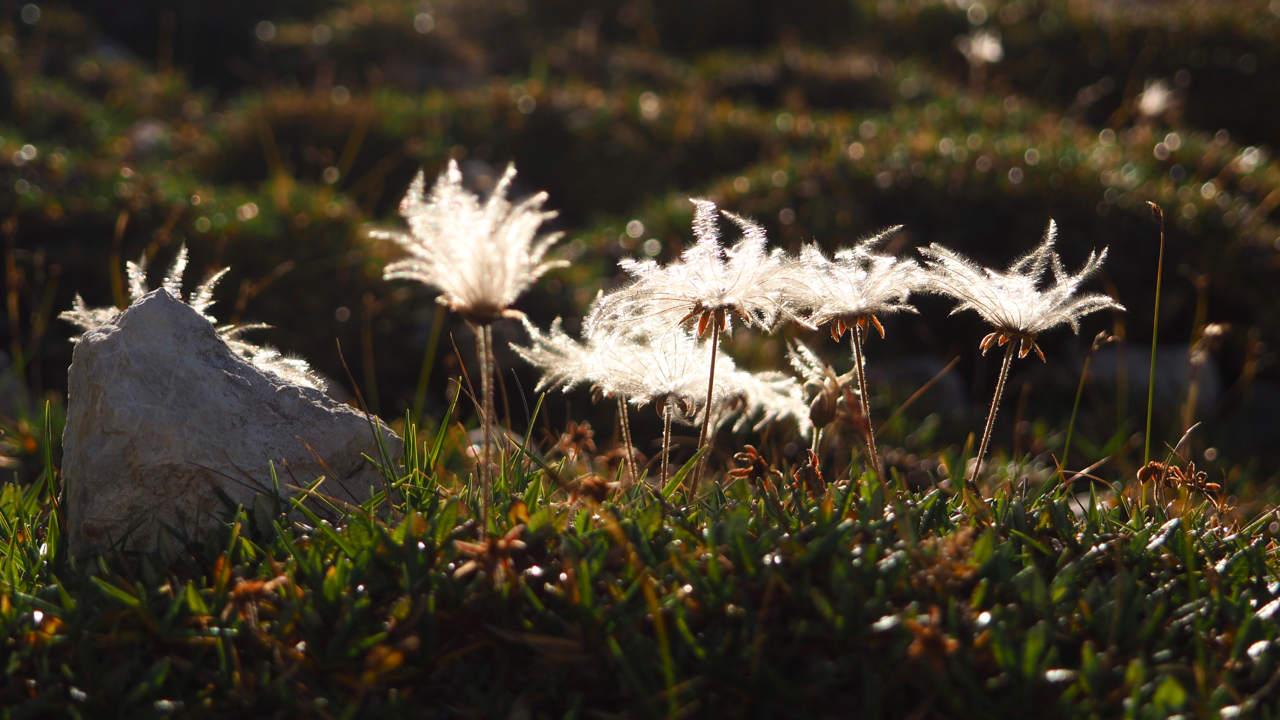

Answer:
[0,399,1280,717]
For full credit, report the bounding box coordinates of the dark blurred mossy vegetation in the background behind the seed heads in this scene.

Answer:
[0,0,1280,492]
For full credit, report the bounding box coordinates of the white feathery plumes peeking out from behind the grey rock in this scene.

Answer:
[58,245,328,391]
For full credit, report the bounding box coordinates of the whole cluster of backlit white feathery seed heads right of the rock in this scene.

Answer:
[374,163,1123,492]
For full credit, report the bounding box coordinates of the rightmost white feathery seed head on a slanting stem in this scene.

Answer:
[920,220,1124,341]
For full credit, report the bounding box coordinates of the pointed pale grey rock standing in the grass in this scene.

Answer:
[63,290,403,555]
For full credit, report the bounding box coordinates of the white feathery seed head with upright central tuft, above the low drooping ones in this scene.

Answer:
[586,200,809,336]
